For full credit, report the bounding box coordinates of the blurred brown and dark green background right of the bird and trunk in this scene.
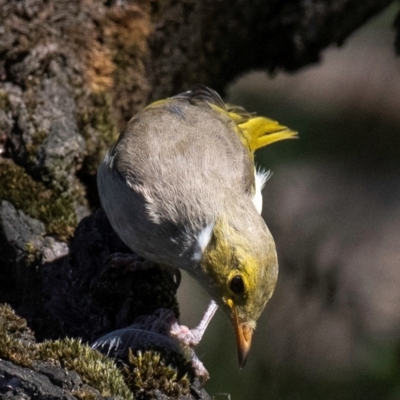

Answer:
[179,5,400,400]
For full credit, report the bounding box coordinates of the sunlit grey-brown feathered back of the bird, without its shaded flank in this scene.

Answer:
[114,99,254,223]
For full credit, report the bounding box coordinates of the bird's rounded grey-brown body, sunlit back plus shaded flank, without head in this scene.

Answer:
[98,99,254,269]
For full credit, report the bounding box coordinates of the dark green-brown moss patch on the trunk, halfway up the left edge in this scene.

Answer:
[0,160,77,240]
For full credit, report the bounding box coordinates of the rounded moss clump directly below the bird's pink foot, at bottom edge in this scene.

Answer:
[123,349,193,400]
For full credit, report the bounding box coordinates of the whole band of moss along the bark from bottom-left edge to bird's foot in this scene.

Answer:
[0,305,195,400]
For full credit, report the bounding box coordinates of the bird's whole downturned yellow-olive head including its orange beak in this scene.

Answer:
[195,212,278,368]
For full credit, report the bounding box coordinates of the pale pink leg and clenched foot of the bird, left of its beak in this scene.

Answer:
[170,300,218,347]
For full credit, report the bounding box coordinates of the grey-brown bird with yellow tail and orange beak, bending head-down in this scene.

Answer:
[97,85,297,368]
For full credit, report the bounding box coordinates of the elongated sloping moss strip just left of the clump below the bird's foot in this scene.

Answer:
[38,339,133,399]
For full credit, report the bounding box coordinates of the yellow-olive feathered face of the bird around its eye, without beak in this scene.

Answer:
[200,214,277,324]
